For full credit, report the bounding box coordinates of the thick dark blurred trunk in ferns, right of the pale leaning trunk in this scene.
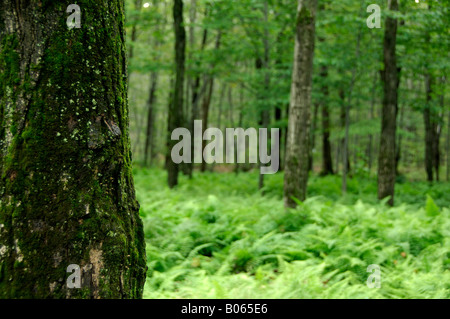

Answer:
[378,0,400,205]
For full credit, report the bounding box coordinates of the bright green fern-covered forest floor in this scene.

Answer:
[134,168,450,299]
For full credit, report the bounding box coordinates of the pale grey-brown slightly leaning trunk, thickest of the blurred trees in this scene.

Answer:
[284,0,317,207]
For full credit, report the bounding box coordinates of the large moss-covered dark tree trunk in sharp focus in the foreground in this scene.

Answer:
[0,0,146,298]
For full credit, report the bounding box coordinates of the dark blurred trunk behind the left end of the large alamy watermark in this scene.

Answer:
[166,0,186,188]
